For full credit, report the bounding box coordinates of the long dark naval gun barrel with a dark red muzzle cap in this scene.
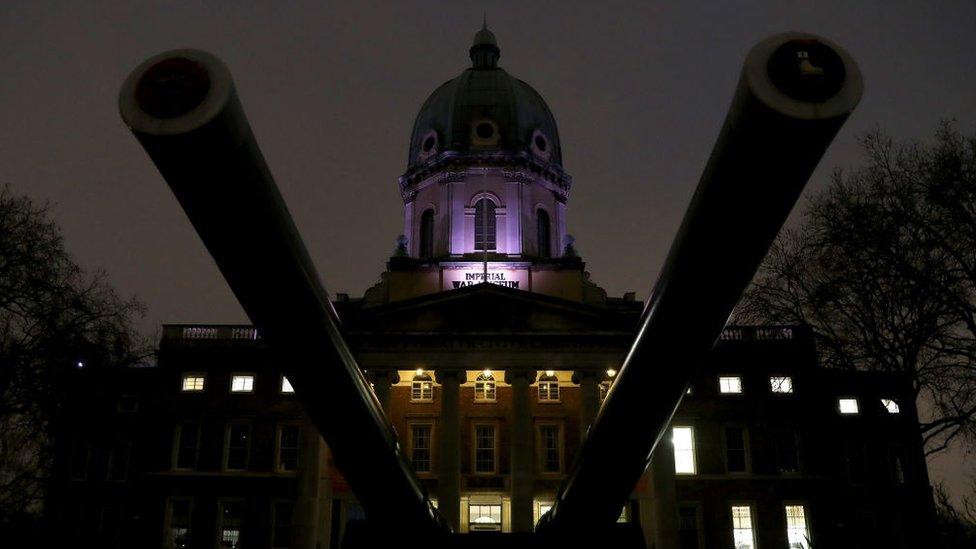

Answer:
[119,50,450,541]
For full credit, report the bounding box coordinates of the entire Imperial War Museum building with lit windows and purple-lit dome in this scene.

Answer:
[48,24,931,549]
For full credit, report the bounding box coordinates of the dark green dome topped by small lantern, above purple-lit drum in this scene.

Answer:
[407,27,562,171]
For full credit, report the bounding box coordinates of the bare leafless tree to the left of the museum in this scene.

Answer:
[0,185,148,530]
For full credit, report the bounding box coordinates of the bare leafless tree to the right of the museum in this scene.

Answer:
[737,122,976,454]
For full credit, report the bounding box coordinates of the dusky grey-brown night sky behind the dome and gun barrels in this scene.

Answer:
[0,0,976,500]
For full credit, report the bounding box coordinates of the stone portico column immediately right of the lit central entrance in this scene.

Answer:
[505,370,535,532]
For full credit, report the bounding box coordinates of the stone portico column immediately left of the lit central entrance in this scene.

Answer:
[434,370,467,530]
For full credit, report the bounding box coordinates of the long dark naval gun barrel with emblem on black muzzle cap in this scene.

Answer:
[536,33,863,539]
